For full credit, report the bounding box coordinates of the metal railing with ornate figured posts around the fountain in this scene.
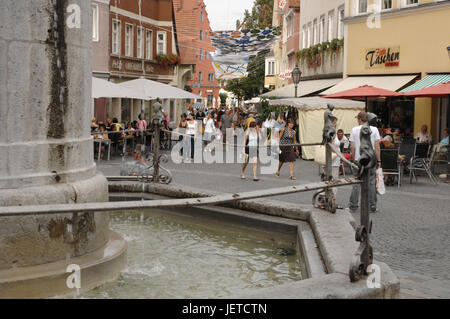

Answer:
[0,106,376,282]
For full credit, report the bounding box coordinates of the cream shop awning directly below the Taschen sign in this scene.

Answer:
[320,75,417,95]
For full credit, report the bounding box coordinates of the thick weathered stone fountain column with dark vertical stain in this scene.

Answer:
[0,0,126,298]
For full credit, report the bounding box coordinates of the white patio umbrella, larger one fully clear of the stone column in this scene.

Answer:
[119,78,202,99]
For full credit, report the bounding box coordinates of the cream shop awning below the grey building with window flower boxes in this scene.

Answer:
[261,79,342,99]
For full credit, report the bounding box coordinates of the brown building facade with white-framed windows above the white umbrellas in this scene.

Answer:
[92,0,193,126]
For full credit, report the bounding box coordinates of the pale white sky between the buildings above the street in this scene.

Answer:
[204,0,254,31]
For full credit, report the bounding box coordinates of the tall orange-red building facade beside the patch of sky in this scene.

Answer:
[174,0,220,107]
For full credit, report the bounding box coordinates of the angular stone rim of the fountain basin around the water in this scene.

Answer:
[109,182,400,299]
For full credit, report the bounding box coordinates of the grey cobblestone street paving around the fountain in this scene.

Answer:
[98,151,450,298]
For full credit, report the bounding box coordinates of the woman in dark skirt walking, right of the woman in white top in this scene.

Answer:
[275,119,300,181]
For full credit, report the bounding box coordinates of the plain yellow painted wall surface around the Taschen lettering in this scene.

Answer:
[345,0,450,134]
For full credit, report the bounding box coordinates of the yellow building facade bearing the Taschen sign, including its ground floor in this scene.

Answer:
[336,0,450,142]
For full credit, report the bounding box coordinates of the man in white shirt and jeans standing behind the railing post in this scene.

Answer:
[349,112,381,213]
